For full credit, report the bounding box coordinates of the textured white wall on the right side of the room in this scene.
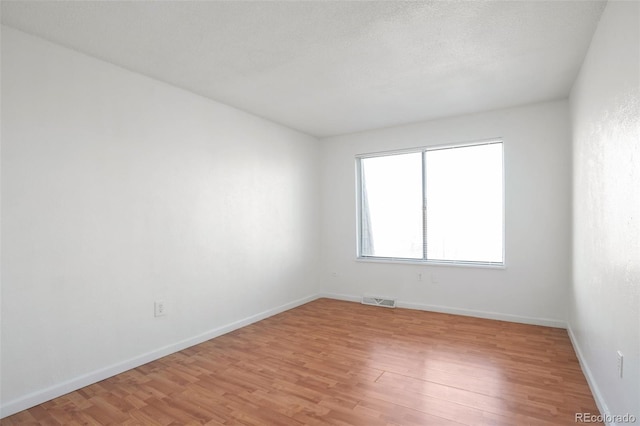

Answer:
[569,1,640,421]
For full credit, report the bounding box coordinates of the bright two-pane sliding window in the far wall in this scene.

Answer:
[357,141,504,265]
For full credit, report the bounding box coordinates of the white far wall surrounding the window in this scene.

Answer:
[320,101,571,326]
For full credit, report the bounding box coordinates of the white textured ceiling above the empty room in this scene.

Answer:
[1,0,604,136]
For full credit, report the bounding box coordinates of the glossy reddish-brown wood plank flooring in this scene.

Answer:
[2,299,598,426]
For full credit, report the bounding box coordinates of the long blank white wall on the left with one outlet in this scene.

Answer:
[1,27,319,415]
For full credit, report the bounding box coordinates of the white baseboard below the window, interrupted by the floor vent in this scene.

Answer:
[318,293,567,328]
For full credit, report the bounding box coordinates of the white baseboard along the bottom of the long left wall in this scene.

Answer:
[0,295,317,418]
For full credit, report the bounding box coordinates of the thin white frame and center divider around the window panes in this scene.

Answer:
[355,137,507,269]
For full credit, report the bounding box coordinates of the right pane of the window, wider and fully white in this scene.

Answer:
[425,143,503,262]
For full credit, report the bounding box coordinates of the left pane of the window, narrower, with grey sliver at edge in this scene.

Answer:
[360,152,423,259]
